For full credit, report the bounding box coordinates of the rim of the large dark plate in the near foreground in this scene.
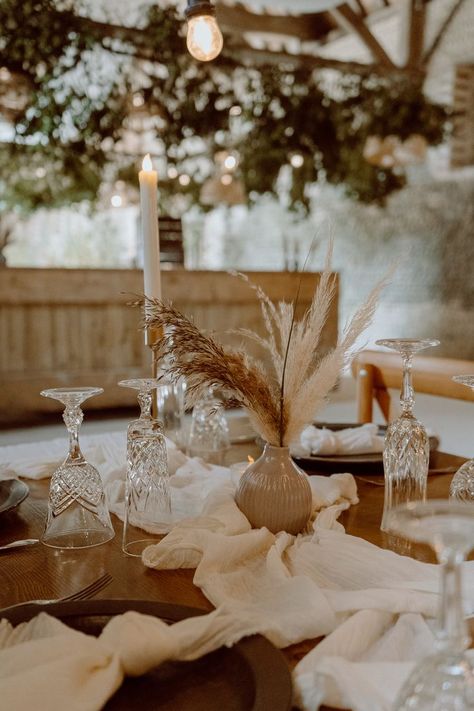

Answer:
[2,598,293,711]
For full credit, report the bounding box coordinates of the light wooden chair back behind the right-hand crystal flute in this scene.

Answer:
[352,350,474,422]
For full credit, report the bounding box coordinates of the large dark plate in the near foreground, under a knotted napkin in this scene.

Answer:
[1,600,291,711]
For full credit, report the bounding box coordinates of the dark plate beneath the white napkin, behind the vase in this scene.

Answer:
[293,422,439,474]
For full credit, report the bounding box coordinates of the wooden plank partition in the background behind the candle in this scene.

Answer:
[0,269,337,425]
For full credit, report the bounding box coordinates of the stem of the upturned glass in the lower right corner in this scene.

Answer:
[437,548,470,653]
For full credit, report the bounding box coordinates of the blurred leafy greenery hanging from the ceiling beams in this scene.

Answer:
[0,0,447,210]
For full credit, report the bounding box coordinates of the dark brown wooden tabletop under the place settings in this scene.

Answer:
[0,445,465,708]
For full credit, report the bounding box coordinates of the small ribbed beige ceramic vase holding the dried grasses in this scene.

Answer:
[235,444,312,534]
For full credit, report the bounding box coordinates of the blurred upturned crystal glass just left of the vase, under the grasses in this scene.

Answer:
[188,388,230,464]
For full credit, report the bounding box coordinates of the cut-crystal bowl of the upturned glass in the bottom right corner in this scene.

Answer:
[393,652,474,711]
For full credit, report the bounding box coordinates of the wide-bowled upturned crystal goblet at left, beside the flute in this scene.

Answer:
[41,388,115,548]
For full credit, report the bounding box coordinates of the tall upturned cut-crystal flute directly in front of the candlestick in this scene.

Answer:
[119,378,171,557]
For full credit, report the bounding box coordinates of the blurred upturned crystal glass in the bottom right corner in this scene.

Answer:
[387,499,474,711]
